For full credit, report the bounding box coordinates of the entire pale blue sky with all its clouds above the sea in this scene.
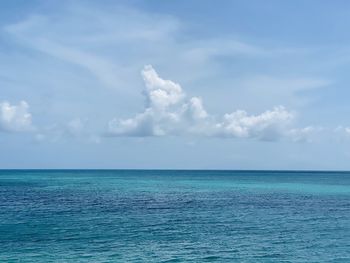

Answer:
[0,0,350,170]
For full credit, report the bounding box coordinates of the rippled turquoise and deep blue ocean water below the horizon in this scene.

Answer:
[0,170,350,262]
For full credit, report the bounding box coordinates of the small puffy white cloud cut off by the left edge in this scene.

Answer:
[0,101,33,132]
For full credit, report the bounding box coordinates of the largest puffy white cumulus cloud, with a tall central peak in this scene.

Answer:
[108,65,296,140]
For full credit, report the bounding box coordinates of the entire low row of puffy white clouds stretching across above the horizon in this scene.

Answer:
[0,65,342,143]
